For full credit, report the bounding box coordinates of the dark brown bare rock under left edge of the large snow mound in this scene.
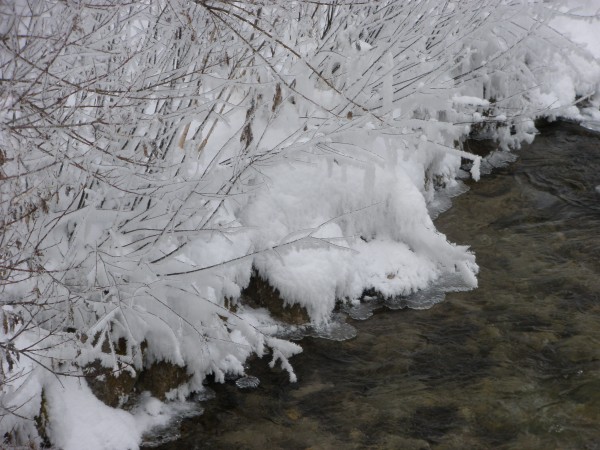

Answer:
[241,271,310,325]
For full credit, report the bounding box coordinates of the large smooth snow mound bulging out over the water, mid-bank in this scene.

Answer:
[242,149,477,323]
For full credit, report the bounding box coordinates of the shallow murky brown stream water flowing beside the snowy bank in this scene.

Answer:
[149,123,600,449]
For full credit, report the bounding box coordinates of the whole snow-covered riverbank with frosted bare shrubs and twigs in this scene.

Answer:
[0,0,600,450]
